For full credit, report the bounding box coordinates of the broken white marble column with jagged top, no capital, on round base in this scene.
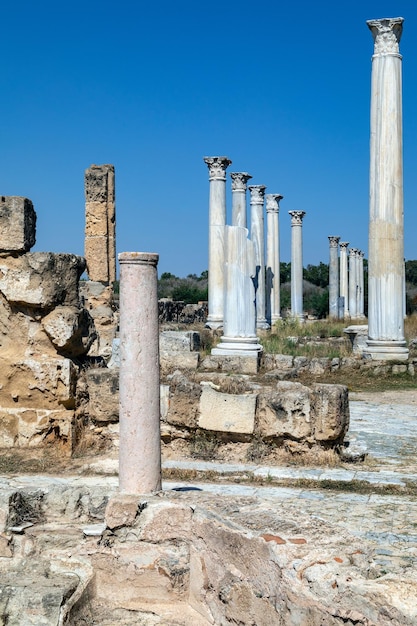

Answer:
[211,226,262,358]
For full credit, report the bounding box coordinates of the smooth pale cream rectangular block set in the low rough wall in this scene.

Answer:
[198,386,257,434]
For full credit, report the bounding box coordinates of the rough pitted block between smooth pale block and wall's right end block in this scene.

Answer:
[257,381,312,440]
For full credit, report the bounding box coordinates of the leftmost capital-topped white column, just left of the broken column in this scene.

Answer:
[204,157,231,328]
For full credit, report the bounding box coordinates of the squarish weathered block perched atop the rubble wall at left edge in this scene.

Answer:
[0,196,36,253]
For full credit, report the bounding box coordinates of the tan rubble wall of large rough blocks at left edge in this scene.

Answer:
[0,196,96,453]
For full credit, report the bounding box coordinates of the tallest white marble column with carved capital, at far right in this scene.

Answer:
[367,17,408,360]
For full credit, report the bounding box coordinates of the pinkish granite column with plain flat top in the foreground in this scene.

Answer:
[119,252,161,494]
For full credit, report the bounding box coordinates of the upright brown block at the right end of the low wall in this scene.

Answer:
[311,383,349,441]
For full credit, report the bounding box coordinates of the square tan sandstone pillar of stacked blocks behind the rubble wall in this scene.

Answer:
[84,165,116,284]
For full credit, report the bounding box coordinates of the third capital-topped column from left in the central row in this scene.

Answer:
[249,185,269,330]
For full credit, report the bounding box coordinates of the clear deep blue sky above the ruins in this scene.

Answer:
[0,0,417,276]
